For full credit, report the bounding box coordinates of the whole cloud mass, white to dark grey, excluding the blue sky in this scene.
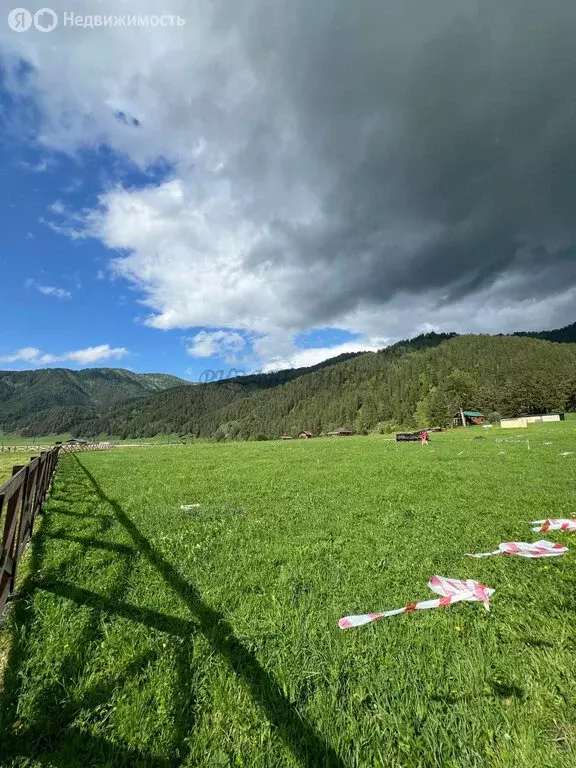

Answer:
[7,0,576,346]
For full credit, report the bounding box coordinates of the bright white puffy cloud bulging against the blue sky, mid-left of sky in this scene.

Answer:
[87,180,298,332]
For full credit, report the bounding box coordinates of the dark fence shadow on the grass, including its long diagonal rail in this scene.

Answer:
[0,455,345,768]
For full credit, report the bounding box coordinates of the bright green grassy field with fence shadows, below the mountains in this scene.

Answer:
[0,422,576,768]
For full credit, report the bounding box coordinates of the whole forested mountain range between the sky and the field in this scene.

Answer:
[0,323,576,440]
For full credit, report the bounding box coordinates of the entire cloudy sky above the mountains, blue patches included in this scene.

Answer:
[0,0,576,379]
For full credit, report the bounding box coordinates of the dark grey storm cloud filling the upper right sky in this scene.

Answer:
[223,0,576,322]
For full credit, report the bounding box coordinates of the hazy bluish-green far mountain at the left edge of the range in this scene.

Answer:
[0,368,185,434]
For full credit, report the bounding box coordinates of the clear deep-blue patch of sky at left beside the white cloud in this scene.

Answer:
[0,140,194,377]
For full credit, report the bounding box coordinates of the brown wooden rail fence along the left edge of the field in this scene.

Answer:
[0,447,59,615]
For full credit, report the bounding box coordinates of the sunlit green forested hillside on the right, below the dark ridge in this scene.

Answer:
[177,336,576,439]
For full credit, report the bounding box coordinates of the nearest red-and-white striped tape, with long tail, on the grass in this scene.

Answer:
[338,576,494,629]
